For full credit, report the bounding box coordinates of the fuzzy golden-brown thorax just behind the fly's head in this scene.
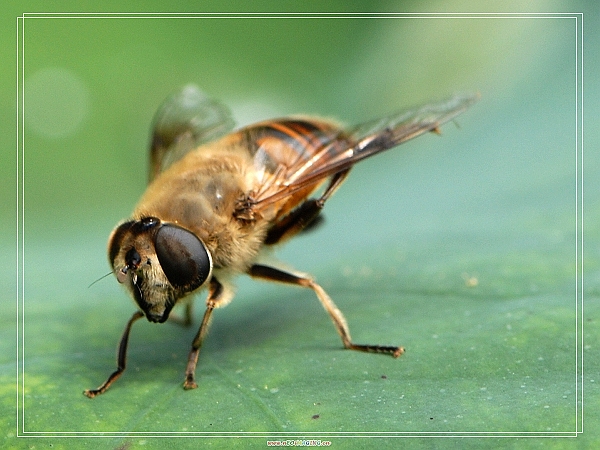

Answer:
[134,146,268,272]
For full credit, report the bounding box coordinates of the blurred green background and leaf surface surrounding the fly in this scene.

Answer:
[0,1,600,448]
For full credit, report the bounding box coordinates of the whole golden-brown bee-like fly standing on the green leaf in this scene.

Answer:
[84,85,478,398]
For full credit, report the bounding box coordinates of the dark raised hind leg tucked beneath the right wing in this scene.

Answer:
[265,169,350,245]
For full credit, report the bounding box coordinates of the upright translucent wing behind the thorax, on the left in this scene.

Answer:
[150,84,234,181]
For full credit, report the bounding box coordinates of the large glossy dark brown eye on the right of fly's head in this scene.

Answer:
[154,224,212,291]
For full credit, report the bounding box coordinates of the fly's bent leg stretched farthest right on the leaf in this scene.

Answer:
[248,264,404,358]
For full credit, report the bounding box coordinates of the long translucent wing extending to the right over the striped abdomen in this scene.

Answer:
[253,94,479,211]
